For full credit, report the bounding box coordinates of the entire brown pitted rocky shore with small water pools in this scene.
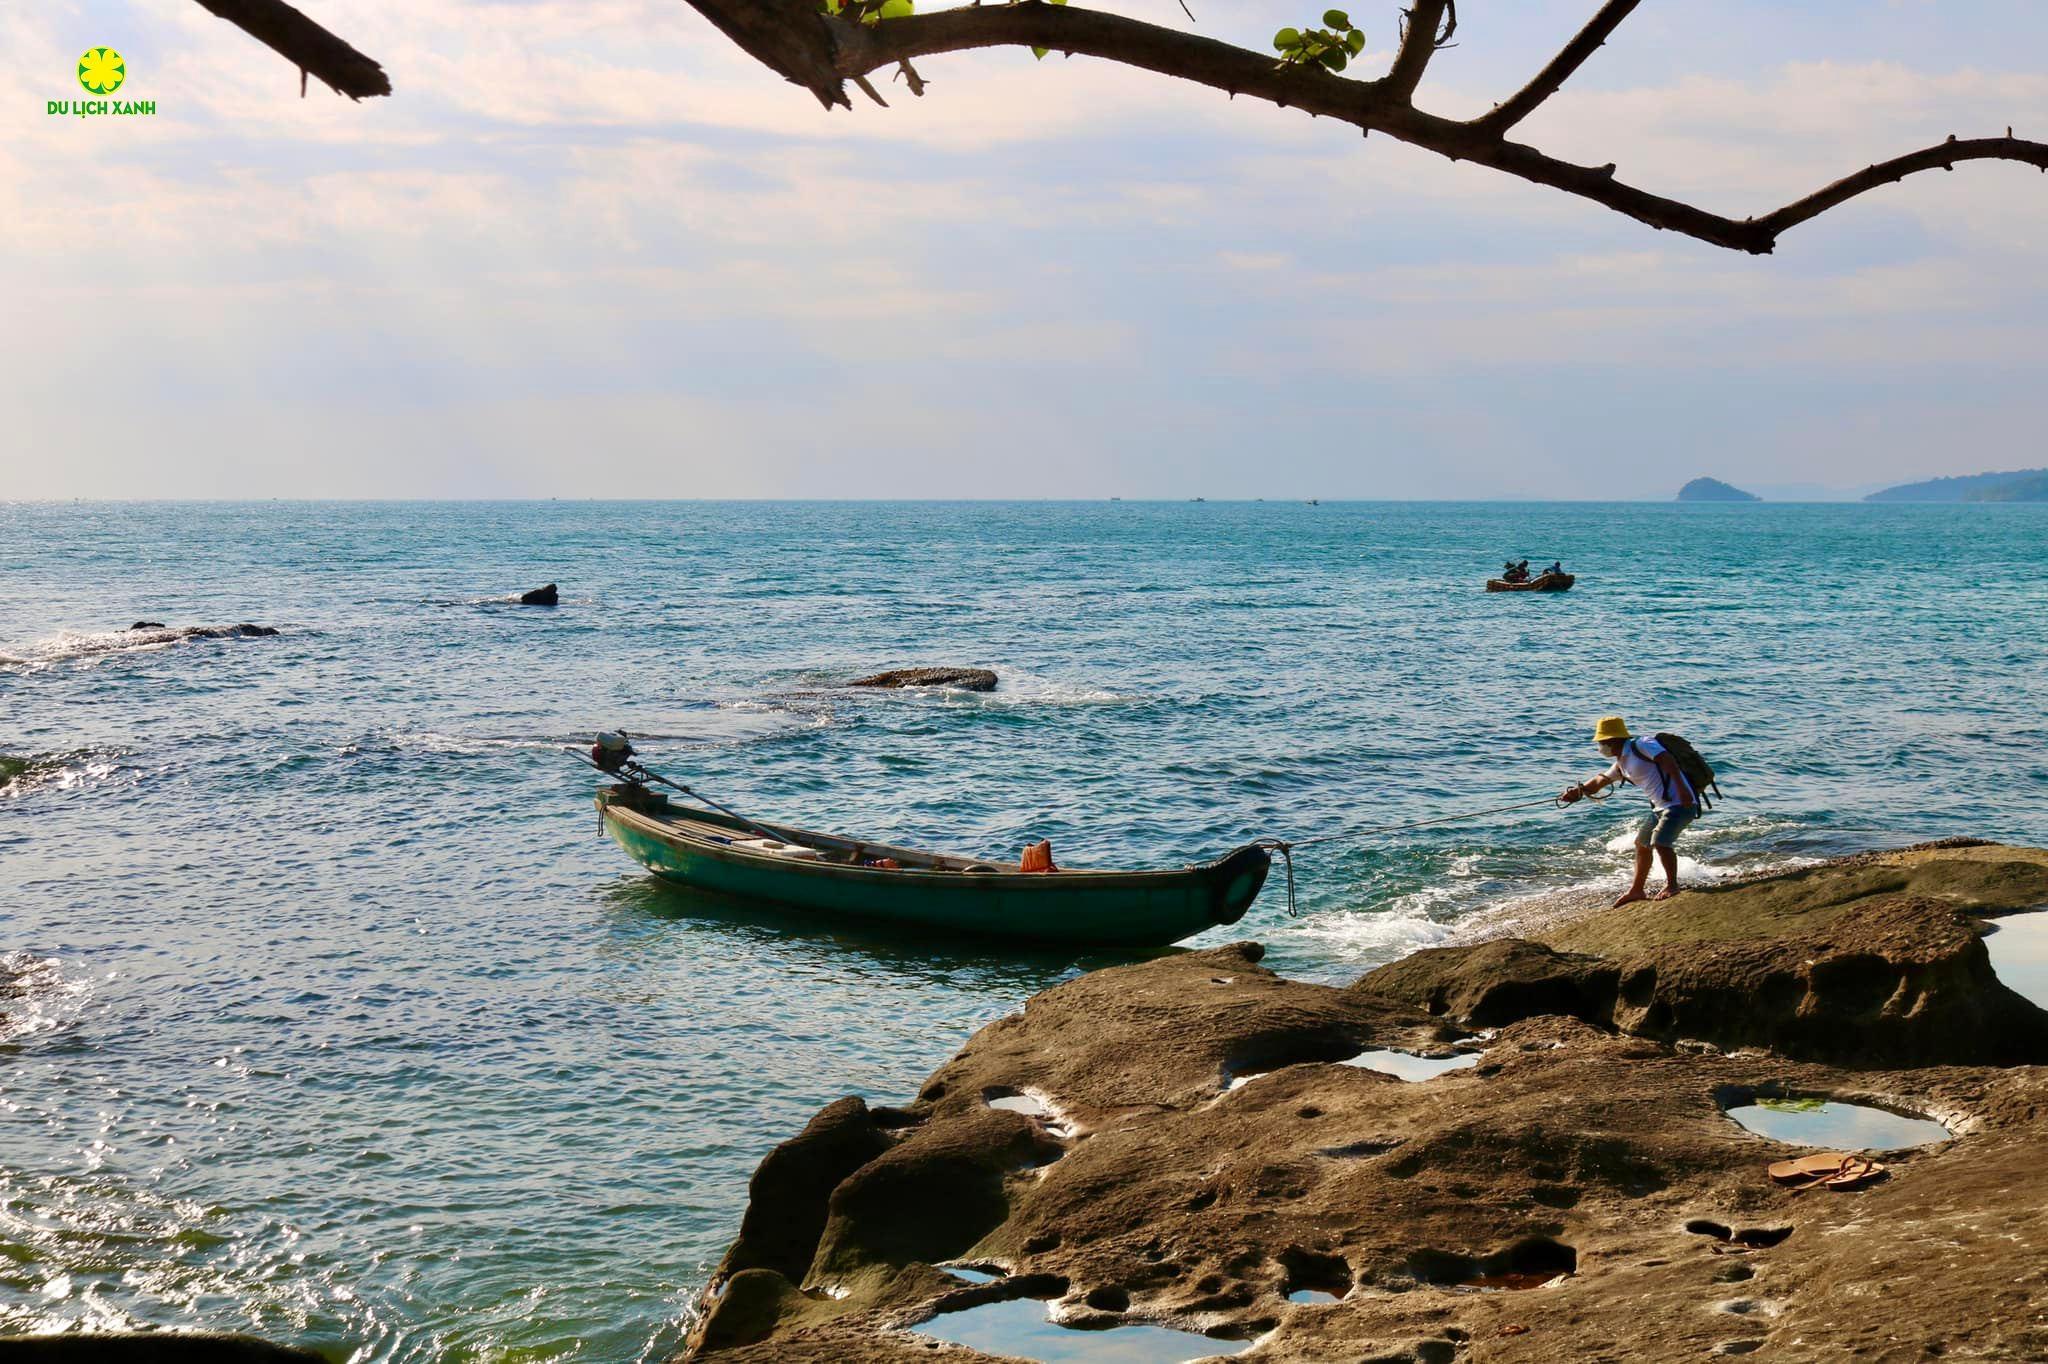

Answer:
[686,842,2048,1364]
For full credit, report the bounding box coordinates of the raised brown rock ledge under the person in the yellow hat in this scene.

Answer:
[1356,844,2048,1065]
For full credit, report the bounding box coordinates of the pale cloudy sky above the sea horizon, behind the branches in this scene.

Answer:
[0,0,2048,498]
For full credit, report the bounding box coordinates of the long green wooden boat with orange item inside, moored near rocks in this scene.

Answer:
[598,784,1272,946]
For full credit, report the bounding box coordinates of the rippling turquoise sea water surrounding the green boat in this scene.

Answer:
[0,502,2048,1362]
